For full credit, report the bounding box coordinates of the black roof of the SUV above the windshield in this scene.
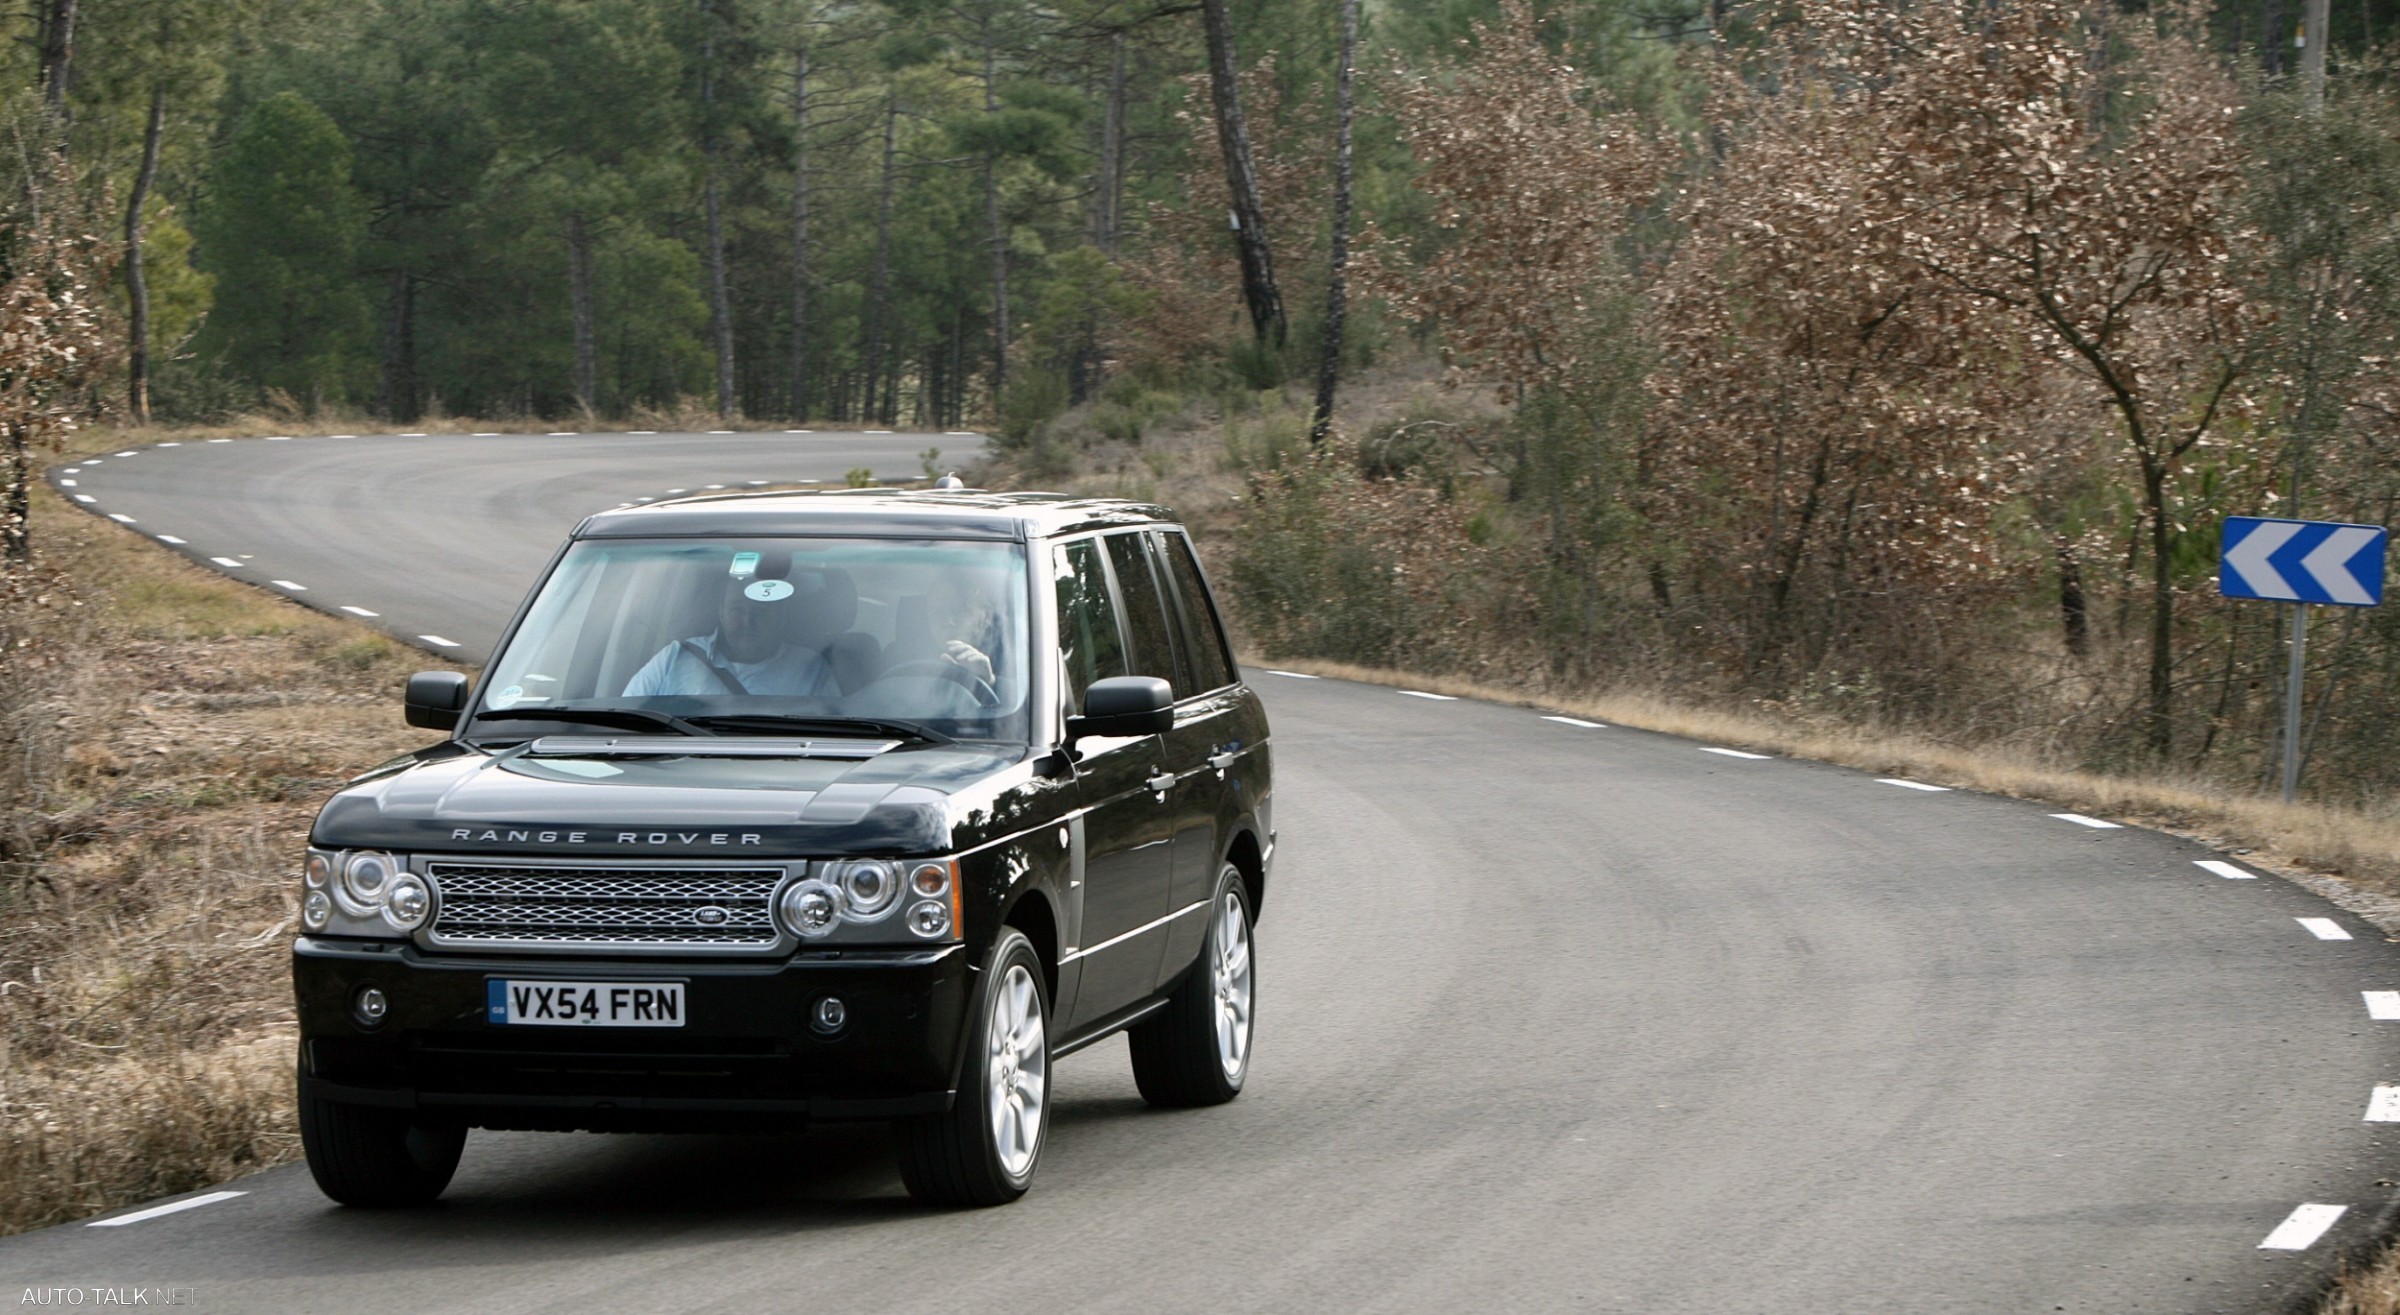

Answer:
[574,490,1176,540]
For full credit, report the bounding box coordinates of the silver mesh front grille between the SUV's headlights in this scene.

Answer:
[425,859,782,953]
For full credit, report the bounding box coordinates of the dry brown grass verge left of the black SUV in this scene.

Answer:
[0,479,463,1233]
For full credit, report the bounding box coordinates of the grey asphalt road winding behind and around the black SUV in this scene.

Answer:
[0,439,2400,1315]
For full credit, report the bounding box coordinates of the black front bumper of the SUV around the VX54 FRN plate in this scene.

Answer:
[293,936,970,1130]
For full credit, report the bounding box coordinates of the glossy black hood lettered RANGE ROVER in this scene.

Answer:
[310,744,1025,859]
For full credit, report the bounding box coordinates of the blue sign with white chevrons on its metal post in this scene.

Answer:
[2218,516,2388,804]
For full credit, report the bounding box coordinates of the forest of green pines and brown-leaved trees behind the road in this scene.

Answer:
[0,0,2400,811]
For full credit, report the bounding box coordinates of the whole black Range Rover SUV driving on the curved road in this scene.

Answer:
[293,492,1274,1205]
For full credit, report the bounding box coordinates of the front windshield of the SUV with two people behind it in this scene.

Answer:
[475,538,1027,741]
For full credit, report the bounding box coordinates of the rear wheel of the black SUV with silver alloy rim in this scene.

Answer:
[1126,864,1258,1109]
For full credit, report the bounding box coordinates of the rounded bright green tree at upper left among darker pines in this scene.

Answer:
[194,91,367,403]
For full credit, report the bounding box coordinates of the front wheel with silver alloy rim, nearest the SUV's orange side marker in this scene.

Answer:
[893,926,1051,1207]
